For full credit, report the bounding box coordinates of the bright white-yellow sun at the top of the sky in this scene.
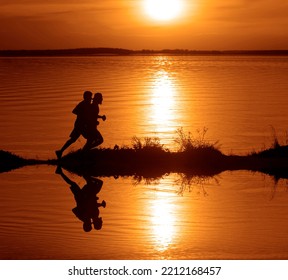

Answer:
[144,0,184,21]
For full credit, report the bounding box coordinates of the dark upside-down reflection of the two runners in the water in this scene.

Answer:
[56,167,106,232]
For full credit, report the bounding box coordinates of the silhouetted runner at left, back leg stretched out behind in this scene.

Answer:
[55,91,92,159]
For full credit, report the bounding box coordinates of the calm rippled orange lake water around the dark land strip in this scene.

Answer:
[0,56,288,259]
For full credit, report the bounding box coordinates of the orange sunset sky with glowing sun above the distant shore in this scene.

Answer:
[0,0,288,50]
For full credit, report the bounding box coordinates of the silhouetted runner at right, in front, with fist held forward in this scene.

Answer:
[83,92,106,151]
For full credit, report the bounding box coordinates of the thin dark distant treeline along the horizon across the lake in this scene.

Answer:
[0,48,288,57]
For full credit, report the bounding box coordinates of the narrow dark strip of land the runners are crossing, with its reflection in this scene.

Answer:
[0,143,288,180]
